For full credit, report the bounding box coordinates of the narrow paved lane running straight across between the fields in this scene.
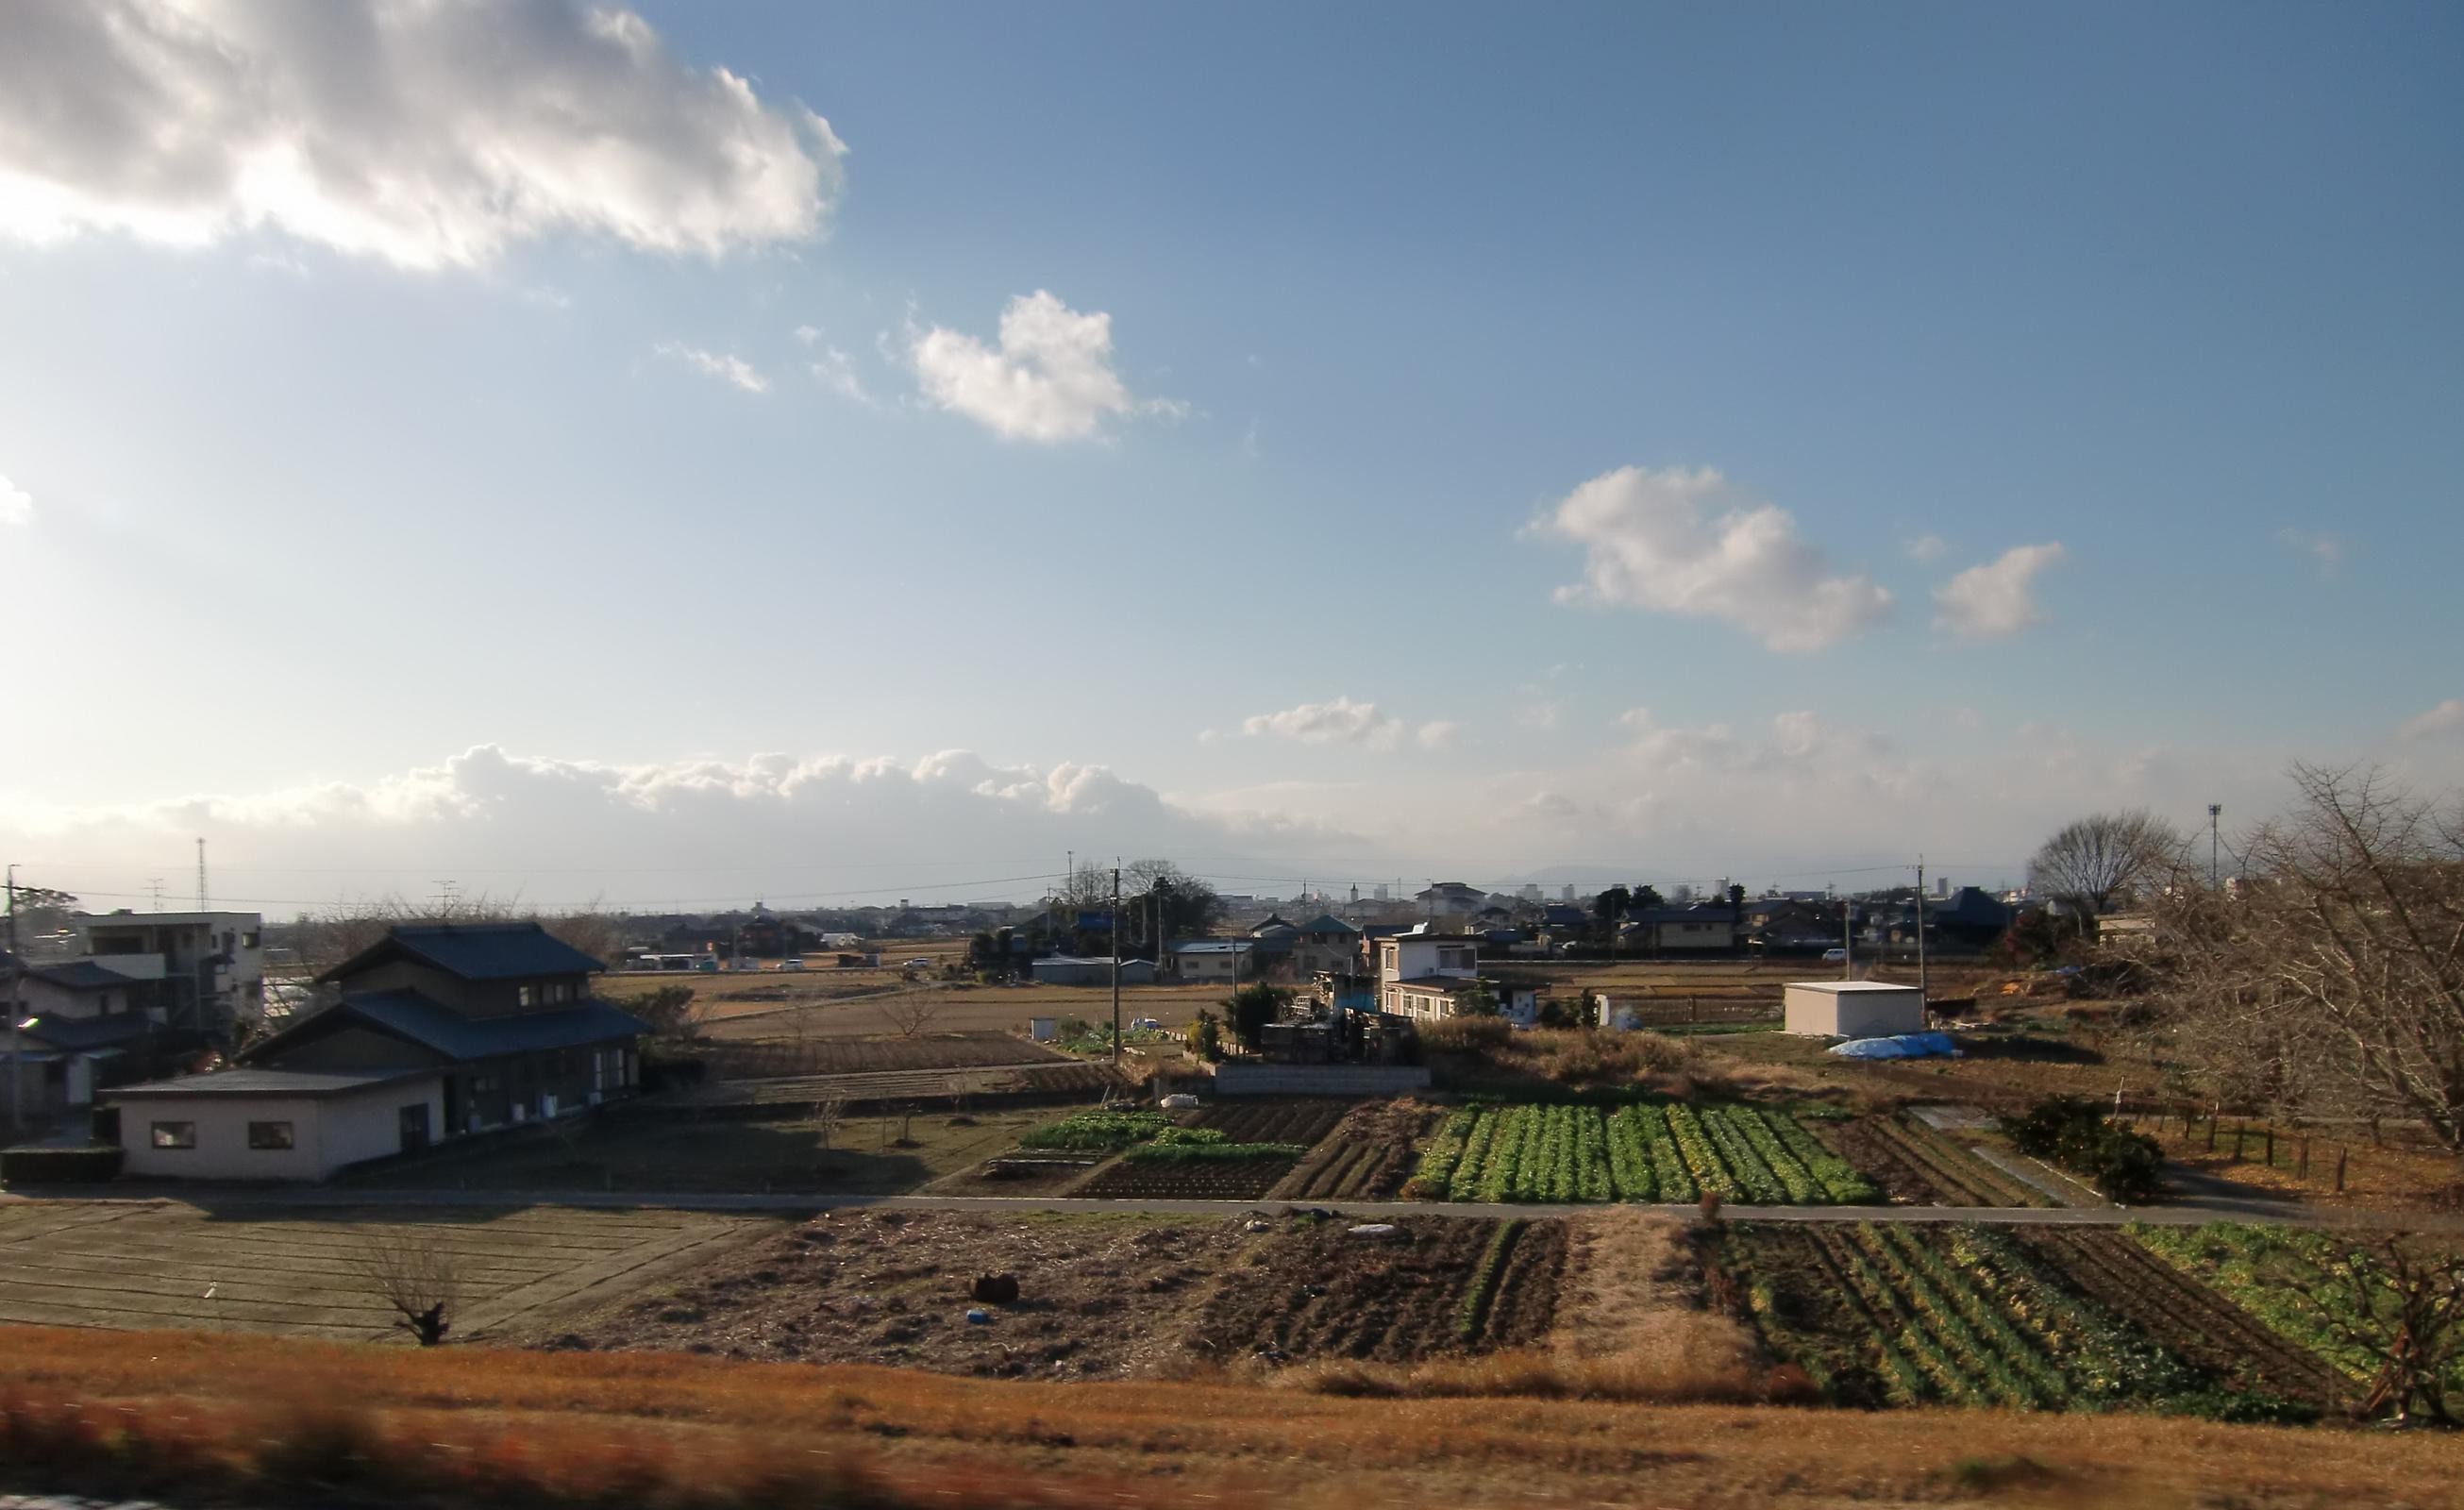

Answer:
[0,1187,2464,1232]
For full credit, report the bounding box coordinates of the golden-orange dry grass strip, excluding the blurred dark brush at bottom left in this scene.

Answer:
[0,1328,2464,1510]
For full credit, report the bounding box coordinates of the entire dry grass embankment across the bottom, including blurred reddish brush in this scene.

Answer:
[0,1328,2455,1507]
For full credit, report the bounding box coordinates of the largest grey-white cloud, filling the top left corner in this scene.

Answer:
[0,0,846,269]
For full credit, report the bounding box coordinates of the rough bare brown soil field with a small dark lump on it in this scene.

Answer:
[497,1212,1259,1380]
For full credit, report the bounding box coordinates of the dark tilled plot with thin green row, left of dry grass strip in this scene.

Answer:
[1190,1216,1567,1365]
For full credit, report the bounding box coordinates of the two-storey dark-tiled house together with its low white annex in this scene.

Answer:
[106,924,650,1180]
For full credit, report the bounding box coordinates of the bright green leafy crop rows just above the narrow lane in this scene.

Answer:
[1404,1103,1878,1207]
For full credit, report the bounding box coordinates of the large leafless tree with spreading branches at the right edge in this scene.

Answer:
[2151,766,2464,1153]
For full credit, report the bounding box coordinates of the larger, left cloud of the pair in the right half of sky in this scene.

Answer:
[1535,465,1890,650]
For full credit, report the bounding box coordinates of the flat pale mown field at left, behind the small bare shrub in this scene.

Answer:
[0,1202,776,1340]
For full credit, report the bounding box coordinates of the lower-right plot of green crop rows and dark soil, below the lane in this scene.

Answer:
[1719,1222,2316,1418]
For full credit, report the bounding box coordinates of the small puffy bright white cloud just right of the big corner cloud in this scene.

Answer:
[907,288,1185,445]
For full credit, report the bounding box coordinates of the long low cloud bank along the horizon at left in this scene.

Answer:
[0,744,1358,914]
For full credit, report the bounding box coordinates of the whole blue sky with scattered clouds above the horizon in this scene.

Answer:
[0,0,2464,914]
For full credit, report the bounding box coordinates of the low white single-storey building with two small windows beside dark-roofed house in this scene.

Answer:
[104,1069,446,1180]
